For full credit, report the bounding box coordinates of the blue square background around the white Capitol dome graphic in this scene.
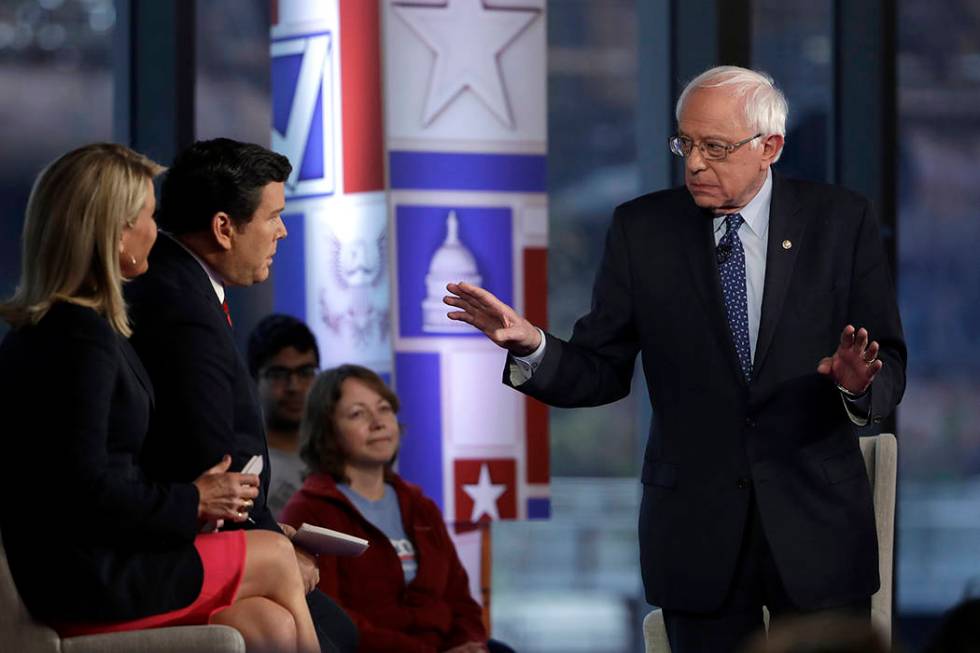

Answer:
[395,206,514,338]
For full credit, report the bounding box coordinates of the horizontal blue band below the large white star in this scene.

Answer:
[389,151,548,193]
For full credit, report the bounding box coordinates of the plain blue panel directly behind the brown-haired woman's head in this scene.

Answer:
[395,353,445,509]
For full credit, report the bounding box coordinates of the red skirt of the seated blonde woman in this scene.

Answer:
[52,531,245,637]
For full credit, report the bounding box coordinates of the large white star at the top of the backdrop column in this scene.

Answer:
[394,0,541,127]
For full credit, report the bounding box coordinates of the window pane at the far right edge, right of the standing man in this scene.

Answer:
[897,0,980,613]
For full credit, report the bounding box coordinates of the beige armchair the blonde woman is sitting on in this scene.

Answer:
[0,524,245,653]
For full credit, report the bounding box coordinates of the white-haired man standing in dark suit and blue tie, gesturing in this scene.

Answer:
[445,66,906,653]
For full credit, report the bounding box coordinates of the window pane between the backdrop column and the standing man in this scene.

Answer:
[548,0,646,476]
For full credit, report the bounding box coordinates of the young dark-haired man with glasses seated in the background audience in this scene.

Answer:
[248,314,320,515]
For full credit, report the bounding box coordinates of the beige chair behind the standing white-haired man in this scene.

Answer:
[643,433,898,653]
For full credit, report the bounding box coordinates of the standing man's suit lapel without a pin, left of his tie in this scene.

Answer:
[681,200,745,383]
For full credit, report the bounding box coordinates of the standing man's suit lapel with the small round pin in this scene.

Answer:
[752,175,812,378]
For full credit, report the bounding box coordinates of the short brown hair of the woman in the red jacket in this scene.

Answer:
[299,365,401,483]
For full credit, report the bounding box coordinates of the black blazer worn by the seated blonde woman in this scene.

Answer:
[0,303,203,622]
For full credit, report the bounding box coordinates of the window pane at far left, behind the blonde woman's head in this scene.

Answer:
[0,0,116,335]
